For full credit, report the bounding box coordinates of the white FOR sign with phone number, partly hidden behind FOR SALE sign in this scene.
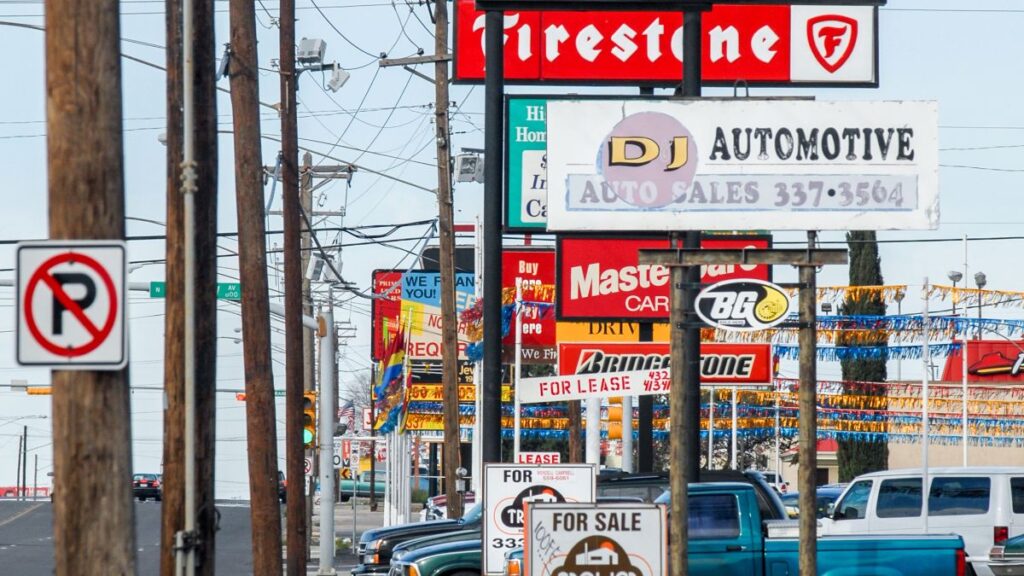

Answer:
[483,464,597,574]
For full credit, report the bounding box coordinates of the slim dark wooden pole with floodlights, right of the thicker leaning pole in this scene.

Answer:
[280,0,307,565]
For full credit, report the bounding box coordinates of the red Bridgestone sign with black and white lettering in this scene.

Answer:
[558,342,772,385]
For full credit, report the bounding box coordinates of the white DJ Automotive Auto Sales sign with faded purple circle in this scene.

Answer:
[547,98,939,231]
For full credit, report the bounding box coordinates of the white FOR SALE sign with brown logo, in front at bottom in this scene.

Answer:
[523,503,669,576]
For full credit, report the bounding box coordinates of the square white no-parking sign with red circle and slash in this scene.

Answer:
[15,241,128,370]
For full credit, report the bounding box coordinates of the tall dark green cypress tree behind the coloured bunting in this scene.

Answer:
[837,232,889,482]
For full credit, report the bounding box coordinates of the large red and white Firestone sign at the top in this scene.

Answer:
[455,0,878,86]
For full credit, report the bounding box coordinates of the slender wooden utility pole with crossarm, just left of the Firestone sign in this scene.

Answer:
[434,1,462,518]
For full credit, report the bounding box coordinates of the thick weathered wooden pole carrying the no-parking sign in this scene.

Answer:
[44,0,136,576]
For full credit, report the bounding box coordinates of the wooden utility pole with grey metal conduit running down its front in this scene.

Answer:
[160,0,217,576]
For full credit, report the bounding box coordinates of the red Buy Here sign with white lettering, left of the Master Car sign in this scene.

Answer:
[502,249,557,364]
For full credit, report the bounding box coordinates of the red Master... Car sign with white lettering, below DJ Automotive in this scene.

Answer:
[556,236,771,322]
